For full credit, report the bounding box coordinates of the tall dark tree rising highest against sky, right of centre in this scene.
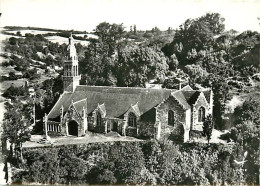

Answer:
[162,13,225,66]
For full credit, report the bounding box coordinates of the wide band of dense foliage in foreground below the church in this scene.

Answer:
[14,141,253,185]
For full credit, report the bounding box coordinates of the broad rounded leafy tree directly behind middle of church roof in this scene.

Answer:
[116,47,168,87]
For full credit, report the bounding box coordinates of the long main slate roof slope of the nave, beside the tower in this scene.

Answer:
[48,85,174,119]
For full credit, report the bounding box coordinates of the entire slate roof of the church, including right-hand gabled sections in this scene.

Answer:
[48,85,210,119]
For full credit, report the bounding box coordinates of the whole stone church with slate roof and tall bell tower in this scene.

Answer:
[45,37,213,142]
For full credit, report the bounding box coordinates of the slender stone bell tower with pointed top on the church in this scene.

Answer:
[63,34,81,92]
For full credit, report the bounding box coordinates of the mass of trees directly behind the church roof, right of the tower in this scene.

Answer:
[80,22,168,87]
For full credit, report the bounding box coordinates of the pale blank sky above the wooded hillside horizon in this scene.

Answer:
[0,0,260,32]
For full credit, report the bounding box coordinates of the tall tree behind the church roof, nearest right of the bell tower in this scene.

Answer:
[80,22,125,86]
